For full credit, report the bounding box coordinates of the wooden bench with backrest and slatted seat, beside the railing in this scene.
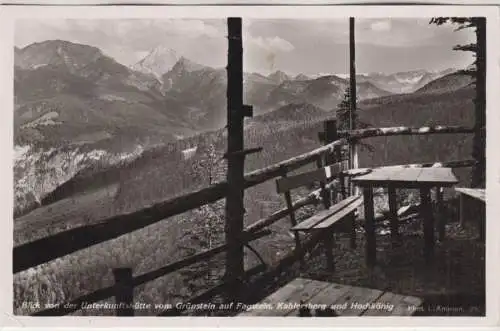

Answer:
[276,161,362,270]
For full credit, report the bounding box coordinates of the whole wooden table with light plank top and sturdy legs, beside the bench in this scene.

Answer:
[352,167,458,266]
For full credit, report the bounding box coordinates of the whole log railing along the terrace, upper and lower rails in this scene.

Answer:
[13,123,476,316]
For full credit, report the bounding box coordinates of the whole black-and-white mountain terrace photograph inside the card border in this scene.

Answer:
[2,6,498,325]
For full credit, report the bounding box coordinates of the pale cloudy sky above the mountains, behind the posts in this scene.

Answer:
[15,18,475,75]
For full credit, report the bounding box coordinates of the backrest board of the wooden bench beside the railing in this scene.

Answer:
[276,161,349,193]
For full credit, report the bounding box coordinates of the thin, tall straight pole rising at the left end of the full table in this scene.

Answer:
[349,17,359,195]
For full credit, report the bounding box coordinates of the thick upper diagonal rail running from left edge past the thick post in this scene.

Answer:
[13,139,347,273]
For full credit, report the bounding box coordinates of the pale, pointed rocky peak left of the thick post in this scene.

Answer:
[131,45,180,79]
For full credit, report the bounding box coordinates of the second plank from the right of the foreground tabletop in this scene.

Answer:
[334,286,384,316]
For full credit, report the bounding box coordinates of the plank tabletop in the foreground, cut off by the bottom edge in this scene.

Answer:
[238,278,423,316]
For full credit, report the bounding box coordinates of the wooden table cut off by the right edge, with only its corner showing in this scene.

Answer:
[455,187,486,241]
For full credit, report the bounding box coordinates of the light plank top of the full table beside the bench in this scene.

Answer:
[352,167,458,187]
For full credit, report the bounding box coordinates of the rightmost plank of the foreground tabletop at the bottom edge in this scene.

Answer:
[363,292,423,316]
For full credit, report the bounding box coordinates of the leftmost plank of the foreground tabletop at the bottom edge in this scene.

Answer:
[239,278,312,316]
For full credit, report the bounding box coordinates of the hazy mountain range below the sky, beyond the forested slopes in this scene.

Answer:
[14,40,470,217]
